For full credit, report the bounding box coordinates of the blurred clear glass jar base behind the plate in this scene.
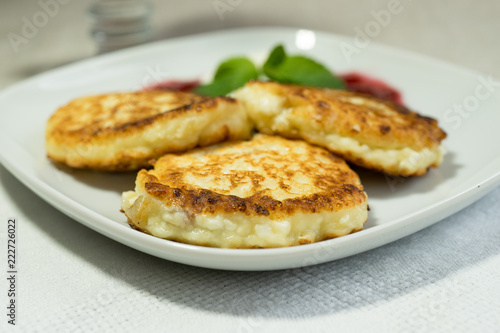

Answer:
[89,0,153,53]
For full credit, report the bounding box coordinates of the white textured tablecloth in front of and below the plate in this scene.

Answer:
[0,168,500,332]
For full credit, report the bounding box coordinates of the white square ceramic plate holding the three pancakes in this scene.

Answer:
[0,28,500,270]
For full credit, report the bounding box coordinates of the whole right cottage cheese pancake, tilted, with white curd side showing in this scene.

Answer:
[233,82,446,176]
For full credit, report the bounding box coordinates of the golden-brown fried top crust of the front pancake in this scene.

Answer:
[137,135,366,219]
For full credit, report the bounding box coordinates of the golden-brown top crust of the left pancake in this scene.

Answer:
[47,91,206,143]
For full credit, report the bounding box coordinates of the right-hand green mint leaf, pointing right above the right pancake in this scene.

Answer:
[263,45,345,89]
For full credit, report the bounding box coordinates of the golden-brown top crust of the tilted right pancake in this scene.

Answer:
[252,81,446,151]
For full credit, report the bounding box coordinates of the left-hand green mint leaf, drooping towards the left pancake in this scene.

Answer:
[194,57,259,96]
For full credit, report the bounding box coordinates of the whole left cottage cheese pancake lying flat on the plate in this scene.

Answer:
[46,91,252,171]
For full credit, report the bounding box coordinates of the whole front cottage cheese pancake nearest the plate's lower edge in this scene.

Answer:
[122,134,367,248]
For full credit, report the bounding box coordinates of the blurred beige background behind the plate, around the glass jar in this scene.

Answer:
[0,0,500,89]
